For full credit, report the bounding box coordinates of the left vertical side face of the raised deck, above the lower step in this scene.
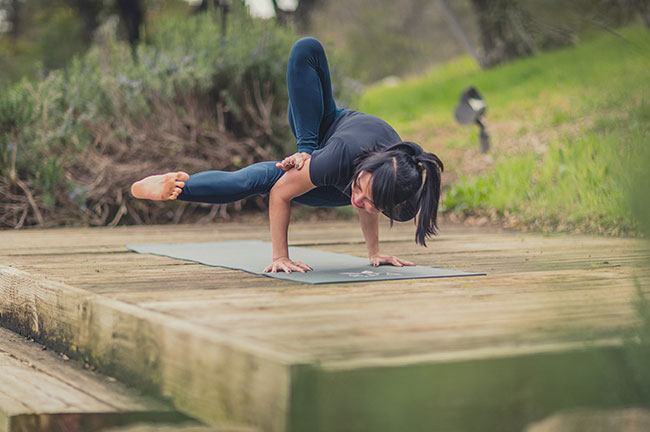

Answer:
[0,265,290,431]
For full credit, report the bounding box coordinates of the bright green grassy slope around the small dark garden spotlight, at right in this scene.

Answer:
[360,27,650,233]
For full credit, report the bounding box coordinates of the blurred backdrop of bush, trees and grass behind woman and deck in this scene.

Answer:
[0,0,650,235]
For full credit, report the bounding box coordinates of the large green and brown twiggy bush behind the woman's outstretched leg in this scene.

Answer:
[0,6,295,227]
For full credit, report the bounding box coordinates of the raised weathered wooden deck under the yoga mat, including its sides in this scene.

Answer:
[0,222,650,431]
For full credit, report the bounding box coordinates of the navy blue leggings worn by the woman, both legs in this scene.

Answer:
[178,38,350,207]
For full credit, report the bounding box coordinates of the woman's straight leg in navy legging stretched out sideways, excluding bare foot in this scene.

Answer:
[178,162,284,204]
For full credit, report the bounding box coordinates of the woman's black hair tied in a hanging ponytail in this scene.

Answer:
[352,141,444,246]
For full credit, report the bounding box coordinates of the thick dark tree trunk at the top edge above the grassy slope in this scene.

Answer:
[472,0,535,68]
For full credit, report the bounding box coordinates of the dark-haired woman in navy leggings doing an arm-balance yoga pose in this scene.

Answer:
[131,38,443,273]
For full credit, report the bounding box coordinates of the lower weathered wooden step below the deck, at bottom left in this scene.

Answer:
[0,329,186,432]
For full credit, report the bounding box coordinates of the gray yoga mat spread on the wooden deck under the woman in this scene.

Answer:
[126,240,484,284]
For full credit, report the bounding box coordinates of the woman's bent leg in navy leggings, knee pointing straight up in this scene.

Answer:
[287,38,337,153]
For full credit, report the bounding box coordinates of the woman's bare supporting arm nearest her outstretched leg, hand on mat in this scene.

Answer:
[264,159,315,273]
